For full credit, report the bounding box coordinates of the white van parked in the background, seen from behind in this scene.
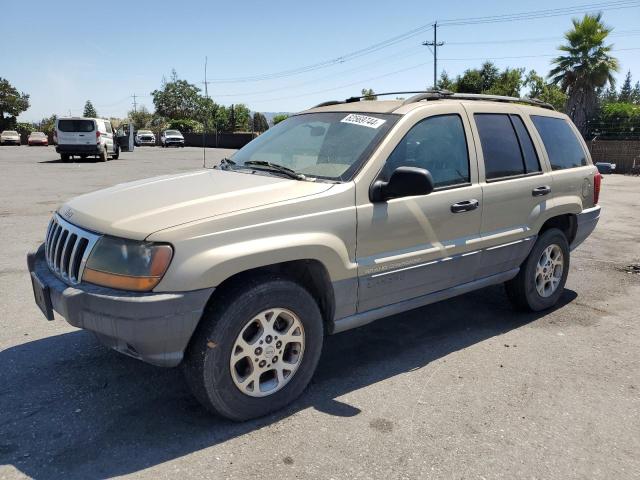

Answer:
[56,117,130,162]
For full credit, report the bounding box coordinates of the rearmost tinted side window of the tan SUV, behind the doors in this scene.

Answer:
[531,115,587,170]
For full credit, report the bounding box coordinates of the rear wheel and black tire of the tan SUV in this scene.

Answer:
[505,228,569,312]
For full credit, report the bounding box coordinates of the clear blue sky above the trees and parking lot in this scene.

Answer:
[5,0,640,121]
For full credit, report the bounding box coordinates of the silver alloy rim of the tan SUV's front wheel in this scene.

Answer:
[229,308,304,397]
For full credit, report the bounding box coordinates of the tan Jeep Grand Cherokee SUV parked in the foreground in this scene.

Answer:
[28,91,600,420]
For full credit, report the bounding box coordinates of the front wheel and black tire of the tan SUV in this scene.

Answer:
[183,276,324,421]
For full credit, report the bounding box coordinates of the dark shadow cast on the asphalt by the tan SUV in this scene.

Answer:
[0,286,577,479]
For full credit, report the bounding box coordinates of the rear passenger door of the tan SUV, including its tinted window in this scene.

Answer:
[465,104,553,278]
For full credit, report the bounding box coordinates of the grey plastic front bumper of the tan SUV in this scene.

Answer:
[27,245,214,367]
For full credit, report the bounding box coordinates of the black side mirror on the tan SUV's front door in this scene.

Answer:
[369,167,433,203]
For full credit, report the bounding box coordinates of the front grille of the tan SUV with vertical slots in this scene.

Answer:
[44,213,100,285]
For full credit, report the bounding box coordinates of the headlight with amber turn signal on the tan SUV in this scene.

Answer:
[82,237,173,292]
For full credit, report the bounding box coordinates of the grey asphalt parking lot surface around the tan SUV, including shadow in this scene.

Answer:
[0,146,640,479]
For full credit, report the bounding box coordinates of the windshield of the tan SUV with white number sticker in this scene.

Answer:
[232,112,399,181]
